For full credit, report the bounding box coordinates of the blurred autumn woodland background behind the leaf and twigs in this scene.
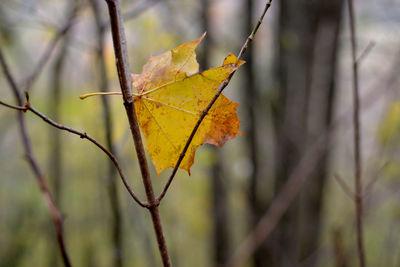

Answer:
[0,0,400,267]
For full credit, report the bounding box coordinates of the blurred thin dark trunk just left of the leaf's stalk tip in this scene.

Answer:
[90,0,123,267]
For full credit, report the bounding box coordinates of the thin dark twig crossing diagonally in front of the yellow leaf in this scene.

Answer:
[157,0,272,202]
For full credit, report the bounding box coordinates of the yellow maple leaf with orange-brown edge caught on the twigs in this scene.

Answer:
[132,34,244,175]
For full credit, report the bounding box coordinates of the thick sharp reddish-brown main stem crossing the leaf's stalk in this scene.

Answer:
[106,0,171,266]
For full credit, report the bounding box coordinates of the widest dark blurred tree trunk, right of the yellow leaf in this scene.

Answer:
[274,0,342,266]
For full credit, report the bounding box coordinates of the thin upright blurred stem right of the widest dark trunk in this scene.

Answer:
[347,0,366,267]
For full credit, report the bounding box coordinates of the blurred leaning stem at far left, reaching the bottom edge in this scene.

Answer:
[0,48,71,267]
